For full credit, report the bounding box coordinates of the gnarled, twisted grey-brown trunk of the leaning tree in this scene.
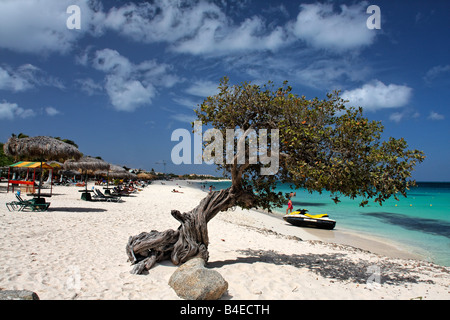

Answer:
[126,186,254,274]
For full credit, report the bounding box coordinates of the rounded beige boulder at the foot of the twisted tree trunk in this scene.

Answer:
[169,258,228,300]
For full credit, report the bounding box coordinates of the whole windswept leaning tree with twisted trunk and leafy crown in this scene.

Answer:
[126,78,425,274]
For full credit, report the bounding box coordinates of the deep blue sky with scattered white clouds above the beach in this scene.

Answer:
[0,0,450,181]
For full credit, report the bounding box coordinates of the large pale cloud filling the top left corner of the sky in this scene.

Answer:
[0,0,103,53]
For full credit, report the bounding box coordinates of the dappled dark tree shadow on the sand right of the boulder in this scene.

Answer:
[208,249,433,285]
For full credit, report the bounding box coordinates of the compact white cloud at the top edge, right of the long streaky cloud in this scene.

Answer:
[290,2,376,51]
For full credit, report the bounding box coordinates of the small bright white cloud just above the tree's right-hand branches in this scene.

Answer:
[342,80,412,111]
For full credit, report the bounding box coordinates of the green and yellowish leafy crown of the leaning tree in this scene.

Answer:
[196,77,425,210]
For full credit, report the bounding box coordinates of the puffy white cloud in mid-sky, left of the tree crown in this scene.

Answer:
[90,49,178,112]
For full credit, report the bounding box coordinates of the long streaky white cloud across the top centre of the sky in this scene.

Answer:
[100,0,288,56]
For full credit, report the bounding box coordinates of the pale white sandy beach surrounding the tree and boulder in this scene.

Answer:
[0,181,450,300]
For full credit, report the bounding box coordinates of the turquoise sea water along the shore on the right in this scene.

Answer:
[200,181,450,266]
